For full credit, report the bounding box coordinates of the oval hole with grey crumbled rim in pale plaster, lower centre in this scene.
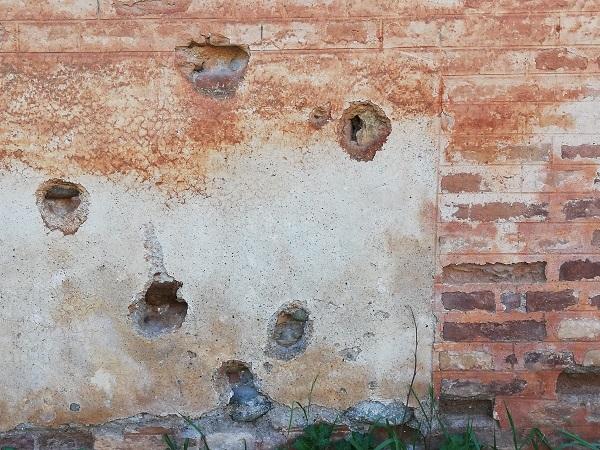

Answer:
[266,303,312,361]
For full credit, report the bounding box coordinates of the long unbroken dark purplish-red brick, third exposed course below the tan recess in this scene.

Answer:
[442,320,546,342]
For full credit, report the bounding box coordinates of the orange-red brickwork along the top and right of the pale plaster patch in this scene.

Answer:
[0,0,600,444]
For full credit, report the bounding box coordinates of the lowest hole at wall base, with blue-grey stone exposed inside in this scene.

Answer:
[217,361,272,422]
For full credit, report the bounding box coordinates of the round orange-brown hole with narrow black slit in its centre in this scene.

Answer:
[340,102,392,161]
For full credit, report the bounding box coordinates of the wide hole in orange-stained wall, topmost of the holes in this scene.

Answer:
[175,36,250,99]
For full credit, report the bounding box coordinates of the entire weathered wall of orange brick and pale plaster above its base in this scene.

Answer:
[0,0,600,448]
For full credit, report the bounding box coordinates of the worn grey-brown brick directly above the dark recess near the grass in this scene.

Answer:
[441,378,527,399]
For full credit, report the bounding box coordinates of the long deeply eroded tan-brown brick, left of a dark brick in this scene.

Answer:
[442,261,546,284]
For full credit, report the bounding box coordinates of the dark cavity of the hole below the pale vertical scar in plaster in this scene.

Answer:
[140,280,188,333]
